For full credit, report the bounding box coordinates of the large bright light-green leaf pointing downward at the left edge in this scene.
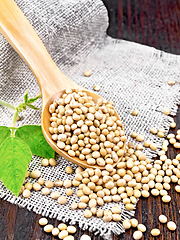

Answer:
[0,137,32,196]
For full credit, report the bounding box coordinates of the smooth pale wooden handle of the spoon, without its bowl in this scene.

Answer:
[0,0,77,104]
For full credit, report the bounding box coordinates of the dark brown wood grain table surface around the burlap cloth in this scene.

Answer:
[0,0,180,240]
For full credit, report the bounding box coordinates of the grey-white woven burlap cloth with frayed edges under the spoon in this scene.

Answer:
[0,0,180,239]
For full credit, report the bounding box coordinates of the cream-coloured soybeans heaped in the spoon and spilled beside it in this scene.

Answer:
[20,89,180,239]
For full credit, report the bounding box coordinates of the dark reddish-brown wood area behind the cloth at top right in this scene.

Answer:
[103,0,180,54]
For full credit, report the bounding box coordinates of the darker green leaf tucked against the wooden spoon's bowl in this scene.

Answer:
[15,125,55,159]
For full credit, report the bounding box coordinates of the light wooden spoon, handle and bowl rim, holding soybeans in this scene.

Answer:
[0,0,125,169]
